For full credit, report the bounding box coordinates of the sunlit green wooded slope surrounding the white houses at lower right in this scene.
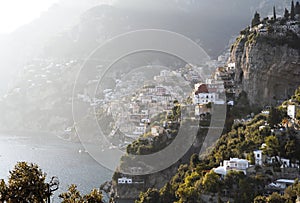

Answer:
[136,88,300,203]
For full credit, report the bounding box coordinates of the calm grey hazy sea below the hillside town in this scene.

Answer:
[0,132,113,202]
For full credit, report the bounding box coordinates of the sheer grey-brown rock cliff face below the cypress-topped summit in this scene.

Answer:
[229,25,300,106]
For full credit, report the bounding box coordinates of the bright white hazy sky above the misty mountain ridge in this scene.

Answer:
[0,0,58,34]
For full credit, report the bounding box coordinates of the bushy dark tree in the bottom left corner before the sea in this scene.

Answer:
[6,162,50,203]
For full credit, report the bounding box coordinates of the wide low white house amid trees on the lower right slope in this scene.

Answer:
[213,158,249,176]
